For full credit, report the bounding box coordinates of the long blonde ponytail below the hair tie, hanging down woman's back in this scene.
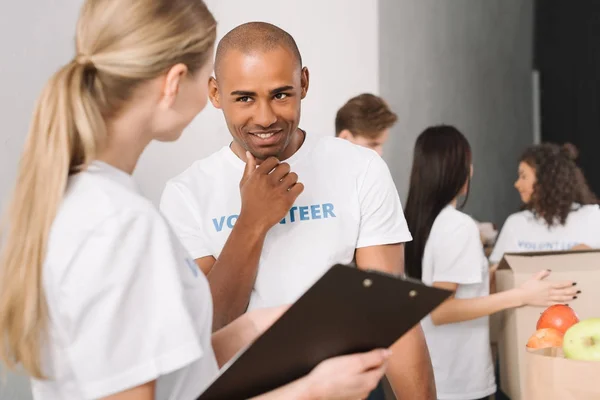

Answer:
[0,61,106,379]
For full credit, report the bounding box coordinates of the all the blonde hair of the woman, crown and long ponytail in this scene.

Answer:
[0,0,216,379]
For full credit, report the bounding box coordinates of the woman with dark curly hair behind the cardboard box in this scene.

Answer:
[490,143,600,263]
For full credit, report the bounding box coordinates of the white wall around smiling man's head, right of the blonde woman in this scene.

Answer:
[135,0,379,205]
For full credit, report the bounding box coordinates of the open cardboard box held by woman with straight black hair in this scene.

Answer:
[492,250,600,400]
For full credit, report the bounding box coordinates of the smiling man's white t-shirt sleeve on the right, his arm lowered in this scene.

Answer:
[356,155,412,248]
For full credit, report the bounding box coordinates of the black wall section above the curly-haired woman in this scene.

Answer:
[535,0,600,198]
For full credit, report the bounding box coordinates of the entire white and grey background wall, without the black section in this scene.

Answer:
[0,0,533,400]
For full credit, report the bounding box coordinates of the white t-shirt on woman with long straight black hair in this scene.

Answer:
[422,206,496,400]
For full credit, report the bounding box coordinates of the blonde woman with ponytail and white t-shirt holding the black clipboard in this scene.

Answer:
[0,0,388,400]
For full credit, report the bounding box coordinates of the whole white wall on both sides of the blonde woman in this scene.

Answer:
[0,0,379,400]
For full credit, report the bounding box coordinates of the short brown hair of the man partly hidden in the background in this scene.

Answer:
[335,93,398,138]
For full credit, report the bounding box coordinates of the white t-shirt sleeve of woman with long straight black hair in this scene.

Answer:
[432,219,485,285]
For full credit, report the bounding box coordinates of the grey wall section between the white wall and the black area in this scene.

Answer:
[379,0,533,225]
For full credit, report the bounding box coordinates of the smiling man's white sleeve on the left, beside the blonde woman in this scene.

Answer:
[160,182,213,260]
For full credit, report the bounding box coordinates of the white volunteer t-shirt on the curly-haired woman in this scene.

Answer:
[490,204,600,264]
